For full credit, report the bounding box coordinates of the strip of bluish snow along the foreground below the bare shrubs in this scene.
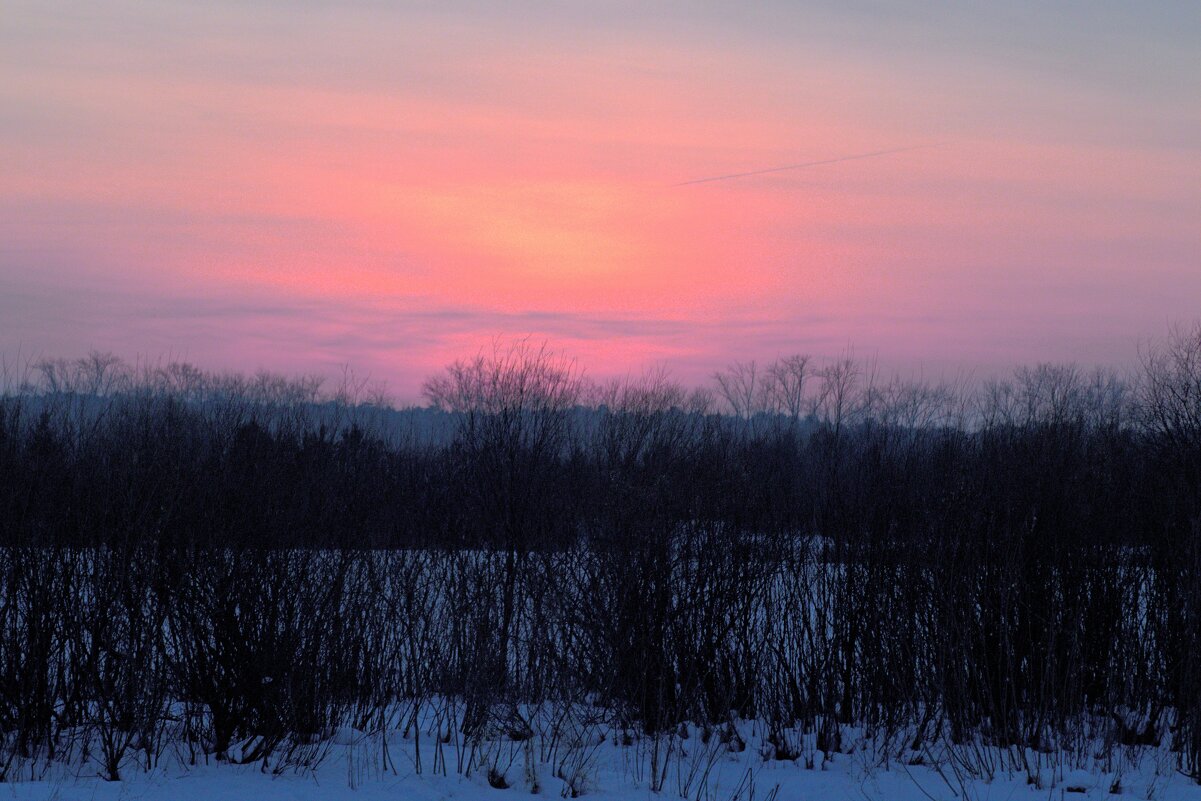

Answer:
[0,724,1201,801]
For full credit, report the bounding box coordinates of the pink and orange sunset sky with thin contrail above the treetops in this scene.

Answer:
[0,0,1201,397]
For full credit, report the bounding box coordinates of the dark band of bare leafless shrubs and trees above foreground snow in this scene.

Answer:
[0,327,1201,785]
